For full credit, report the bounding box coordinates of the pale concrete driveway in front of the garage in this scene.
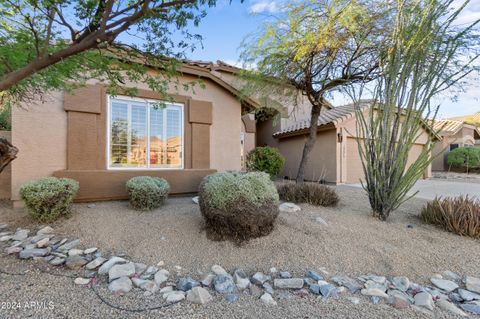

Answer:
[349,179,480,199]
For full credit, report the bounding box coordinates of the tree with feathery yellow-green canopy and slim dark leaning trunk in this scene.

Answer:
[241,0,389,182]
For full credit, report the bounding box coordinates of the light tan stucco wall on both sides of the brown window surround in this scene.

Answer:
[12,72,242,200]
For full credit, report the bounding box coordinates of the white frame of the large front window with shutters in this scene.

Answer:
[106,95,185,171]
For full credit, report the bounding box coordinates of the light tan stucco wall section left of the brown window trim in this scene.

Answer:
[12,92,67,200]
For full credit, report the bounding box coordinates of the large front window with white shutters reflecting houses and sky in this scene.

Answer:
[108,97,183,169]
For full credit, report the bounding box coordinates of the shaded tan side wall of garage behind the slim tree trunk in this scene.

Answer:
[278,129,337,183]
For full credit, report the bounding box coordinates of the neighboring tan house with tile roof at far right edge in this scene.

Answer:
[432,119,480,171]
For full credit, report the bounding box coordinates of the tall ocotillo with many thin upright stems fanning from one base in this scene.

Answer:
[354,0,480,220]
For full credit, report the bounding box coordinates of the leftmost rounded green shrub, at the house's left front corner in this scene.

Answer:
[20,177,79,222]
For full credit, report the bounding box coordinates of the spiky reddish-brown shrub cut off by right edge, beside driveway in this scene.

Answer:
[420,196,480,238]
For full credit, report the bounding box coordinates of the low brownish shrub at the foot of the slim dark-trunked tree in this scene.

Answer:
[277,182,339,206]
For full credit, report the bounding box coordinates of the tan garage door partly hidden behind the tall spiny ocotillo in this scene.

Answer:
[346,137,423,183]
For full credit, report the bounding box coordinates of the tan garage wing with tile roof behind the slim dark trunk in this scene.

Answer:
[257,102,438,184]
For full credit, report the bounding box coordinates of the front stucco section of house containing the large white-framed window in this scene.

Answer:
[0,61,257,205]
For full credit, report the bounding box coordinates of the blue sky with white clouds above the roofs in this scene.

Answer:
[181,0,480,118]
